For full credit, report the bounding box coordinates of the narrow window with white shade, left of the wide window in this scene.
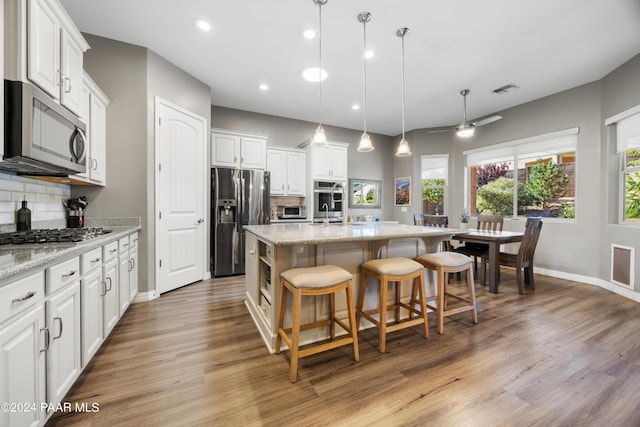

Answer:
[420,154,449,215]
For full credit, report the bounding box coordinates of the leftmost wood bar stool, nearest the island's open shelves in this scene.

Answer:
[276,265,360,383]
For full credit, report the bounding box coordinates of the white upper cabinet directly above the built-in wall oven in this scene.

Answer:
[303,142,349,181]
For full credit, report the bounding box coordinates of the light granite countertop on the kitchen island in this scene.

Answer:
[244,223,464,245]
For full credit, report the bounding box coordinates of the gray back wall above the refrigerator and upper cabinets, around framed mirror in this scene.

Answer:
[211,107,393,219]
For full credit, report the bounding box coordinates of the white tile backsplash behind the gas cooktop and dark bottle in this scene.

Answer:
[0,173,71,232]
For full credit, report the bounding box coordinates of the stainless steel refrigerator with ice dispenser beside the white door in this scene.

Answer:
[211,168,270,277]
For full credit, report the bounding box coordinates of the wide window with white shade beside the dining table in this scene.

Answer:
[464,128,578,218]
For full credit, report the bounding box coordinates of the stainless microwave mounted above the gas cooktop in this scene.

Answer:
[0,80,86,176]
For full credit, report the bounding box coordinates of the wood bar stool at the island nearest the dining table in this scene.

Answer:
[411,252,478,333]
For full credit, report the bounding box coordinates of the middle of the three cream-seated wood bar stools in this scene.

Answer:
[356,258,429,353]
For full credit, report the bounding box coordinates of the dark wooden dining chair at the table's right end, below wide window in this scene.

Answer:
[480,218,542,295]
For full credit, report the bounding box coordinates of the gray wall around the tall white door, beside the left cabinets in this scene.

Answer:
[74,34,211,292]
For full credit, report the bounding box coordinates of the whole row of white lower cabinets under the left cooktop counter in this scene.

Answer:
[0,229,138,426]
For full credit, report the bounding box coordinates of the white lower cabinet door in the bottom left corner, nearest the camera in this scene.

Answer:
[0,304,47,426]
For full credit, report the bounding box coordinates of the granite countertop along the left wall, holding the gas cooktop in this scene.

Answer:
[0,226,141,287]
